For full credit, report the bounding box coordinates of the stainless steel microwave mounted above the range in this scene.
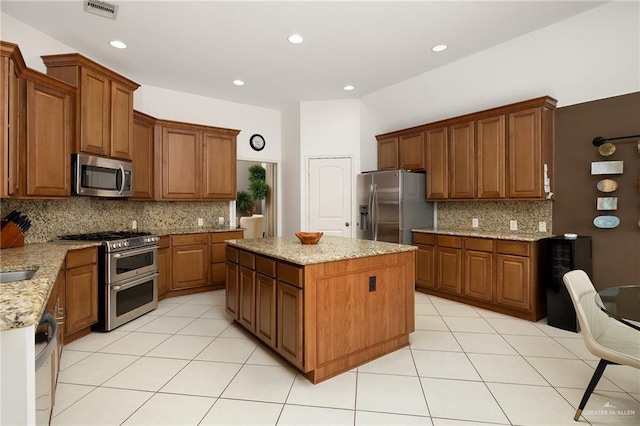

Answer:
[72,154,133,197]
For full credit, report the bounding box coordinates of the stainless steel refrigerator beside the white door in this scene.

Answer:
[356,170,435,244]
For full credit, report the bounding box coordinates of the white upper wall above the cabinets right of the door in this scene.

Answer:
[361,1,640,133]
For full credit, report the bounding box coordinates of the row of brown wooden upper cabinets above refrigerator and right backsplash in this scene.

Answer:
[376,97,557,201]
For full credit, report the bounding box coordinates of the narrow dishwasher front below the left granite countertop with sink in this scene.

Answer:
[35,314,58,425]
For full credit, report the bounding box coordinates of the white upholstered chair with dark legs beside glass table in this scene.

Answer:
[562,270,640,421]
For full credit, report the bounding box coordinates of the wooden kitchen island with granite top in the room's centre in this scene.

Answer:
[226,236,416,383]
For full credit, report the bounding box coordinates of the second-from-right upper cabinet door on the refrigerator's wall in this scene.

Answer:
[476,114,506,199]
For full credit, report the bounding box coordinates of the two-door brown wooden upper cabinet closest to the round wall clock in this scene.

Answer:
[155,120,240,201]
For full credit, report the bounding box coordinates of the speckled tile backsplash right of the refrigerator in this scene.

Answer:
[438,200,553,235]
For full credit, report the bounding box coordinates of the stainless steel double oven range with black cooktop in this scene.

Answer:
[58,231,160,331]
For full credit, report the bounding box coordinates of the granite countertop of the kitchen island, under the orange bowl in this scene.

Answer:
[227,235,418,265]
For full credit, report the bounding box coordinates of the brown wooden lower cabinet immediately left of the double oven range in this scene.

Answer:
[65,247,98,343]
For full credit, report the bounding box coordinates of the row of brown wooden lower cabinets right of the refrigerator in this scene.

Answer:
[413,232,546,321]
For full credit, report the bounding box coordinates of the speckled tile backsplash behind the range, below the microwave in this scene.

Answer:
[0,197,229,243]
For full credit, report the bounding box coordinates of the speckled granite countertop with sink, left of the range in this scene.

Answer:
[0,242,100,331]
